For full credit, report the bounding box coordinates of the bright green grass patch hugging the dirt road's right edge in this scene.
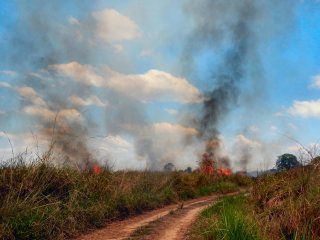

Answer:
[190,195,260,240]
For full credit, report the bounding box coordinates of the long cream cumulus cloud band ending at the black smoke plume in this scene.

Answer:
[49,62,201,103]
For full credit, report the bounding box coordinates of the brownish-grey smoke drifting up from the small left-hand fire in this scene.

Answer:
[0,0,100,169]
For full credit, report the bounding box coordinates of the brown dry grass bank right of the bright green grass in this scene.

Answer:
[251,164,320,239]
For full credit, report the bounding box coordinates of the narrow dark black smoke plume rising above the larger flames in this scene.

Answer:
[187,1,257,144]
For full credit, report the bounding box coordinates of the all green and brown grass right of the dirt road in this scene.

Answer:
[191,157,320,240]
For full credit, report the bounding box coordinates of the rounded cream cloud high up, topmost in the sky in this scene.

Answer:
[92,9,142,43]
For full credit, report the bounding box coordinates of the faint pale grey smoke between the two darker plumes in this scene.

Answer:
[106,93,197,170]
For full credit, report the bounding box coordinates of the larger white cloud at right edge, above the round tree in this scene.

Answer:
[288,99,320,118]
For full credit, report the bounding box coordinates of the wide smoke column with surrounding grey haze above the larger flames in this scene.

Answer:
[183,0,292,167]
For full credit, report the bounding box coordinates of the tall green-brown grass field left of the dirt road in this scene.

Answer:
[0,153,250,239]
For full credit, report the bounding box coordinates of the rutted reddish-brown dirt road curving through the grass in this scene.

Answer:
[77,192,239,240]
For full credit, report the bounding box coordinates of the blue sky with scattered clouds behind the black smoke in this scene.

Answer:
[0,0,320,170]
